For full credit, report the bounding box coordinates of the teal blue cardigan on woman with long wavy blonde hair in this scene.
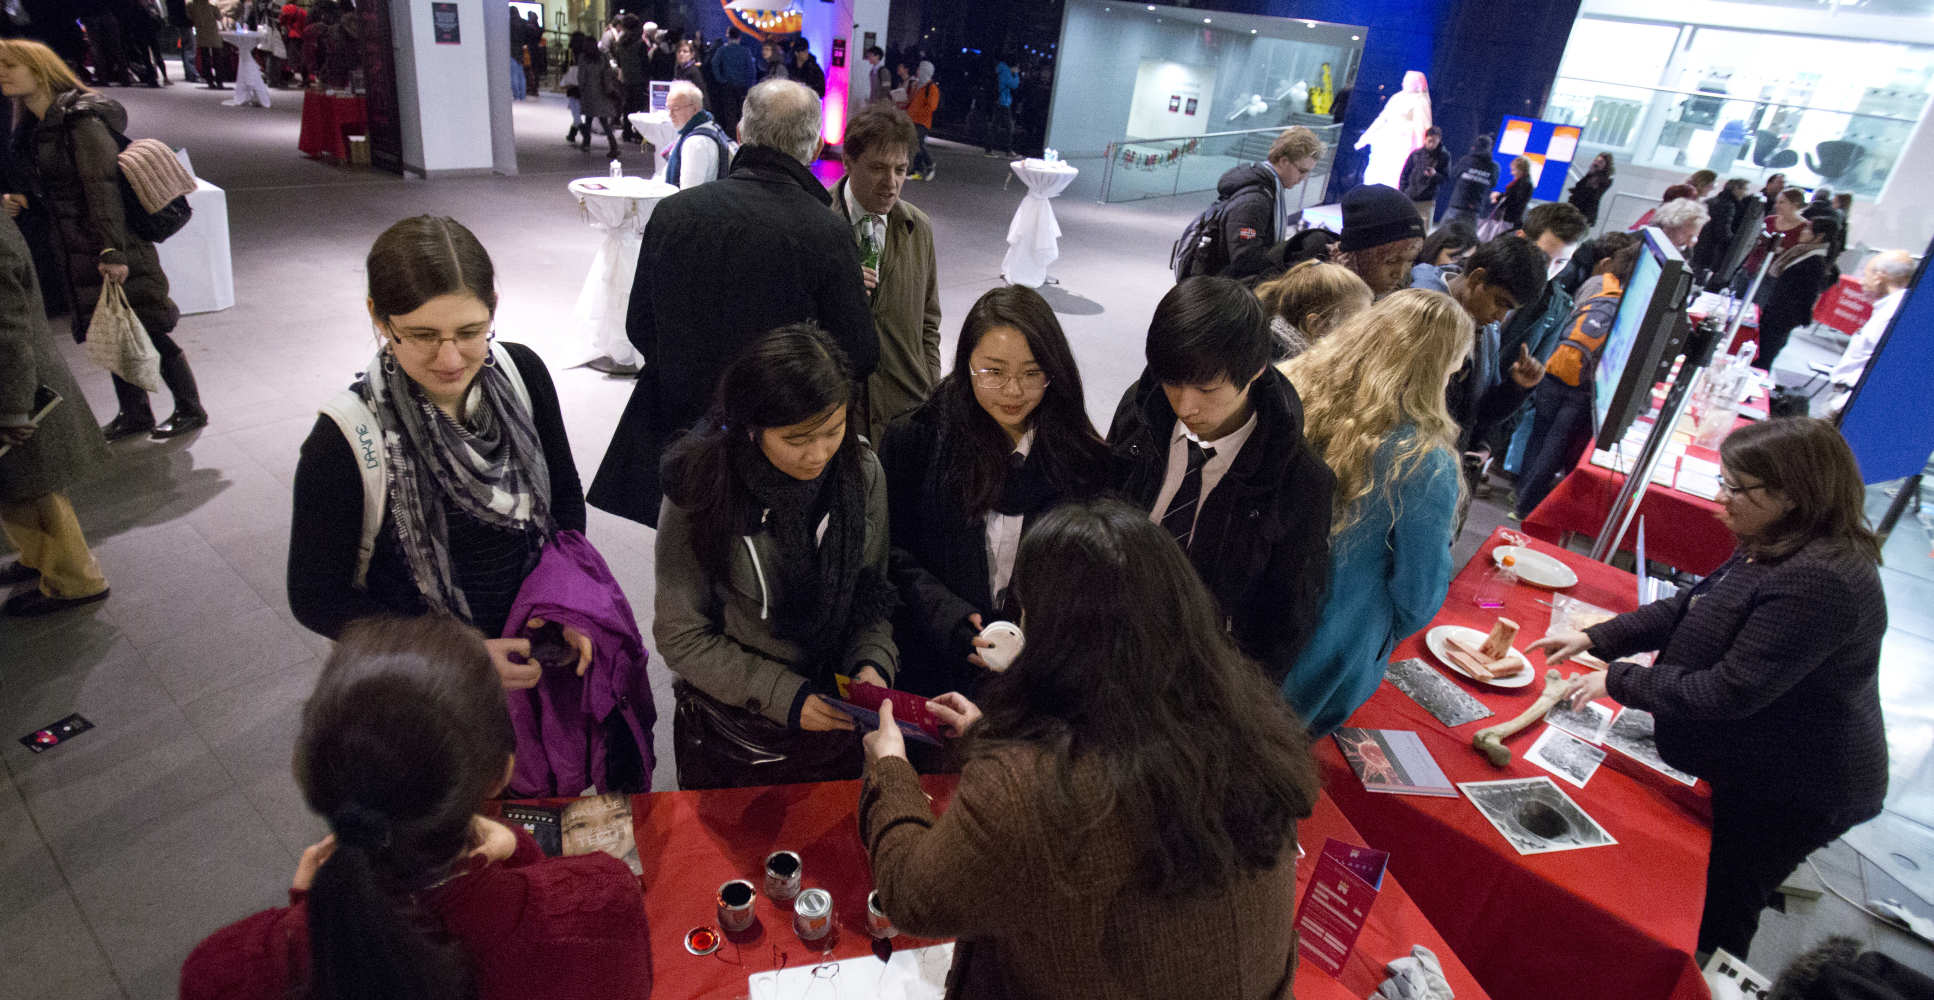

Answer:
[1282,427,1458,739]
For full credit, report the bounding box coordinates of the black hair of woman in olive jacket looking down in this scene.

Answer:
[659,321,861,576]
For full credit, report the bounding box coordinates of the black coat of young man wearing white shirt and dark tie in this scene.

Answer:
[1108,366,1336,685]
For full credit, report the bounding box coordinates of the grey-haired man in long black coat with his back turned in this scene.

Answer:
[586,79,880,528]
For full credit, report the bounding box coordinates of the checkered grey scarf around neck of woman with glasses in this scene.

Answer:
[360,348,557,621]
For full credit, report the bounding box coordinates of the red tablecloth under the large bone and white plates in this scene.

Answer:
[1317,530,1710,1000]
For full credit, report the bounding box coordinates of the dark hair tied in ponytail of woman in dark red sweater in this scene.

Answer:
[294,615,514,1000]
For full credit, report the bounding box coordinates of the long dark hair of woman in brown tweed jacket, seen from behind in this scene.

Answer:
[965,499,1319,897]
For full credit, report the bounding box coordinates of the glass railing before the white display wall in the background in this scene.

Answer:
[1100,122,1342,207]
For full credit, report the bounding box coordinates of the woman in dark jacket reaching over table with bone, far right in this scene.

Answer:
[1539,418,1888,963]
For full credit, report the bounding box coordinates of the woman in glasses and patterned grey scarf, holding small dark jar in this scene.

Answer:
[288,215,590,689]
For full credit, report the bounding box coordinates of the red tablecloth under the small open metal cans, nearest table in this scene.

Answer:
[595,776,1485,1000]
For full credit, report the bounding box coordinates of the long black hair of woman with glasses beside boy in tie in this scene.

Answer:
[932,284,1108,518]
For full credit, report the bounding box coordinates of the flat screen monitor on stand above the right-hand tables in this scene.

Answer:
[1592,226,1690,449]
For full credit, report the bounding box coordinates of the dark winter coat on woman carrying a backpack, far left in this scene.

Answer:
[14,91,182,340]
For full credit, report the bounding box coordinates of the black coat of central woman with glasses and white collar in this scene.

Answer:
[880,400,1108,696]
